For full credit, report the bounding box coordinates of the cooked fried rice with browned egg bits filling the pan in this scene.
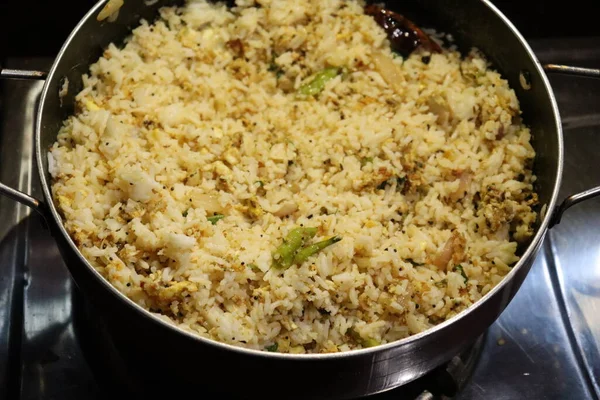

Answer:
[49,0,537,353]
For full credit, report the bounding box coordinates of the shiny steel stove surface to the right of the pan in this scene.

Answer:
[458,38,600,399]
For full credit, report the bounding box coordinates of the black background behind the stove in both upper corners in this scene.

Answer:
[0,0,600,60]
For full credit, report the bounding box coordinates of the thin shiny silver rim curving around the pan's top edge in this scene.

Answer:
[34,0,564,362]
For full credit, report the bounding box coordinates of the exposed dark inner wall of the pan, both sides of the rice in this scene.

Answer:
[37,0,562,354]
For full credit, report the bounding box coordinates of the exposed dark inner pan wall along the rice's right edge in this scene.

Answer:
[388,0,563,247]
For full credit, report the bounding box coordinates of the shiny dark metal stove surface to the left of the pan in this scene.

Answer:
[0,59,100,400]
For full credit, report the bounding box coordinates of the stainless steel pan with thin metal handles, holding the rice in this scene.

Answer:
[0,0,600,399]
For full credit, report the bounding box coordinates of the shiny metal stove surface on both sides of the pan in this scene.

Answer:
[0,38,600,400]
